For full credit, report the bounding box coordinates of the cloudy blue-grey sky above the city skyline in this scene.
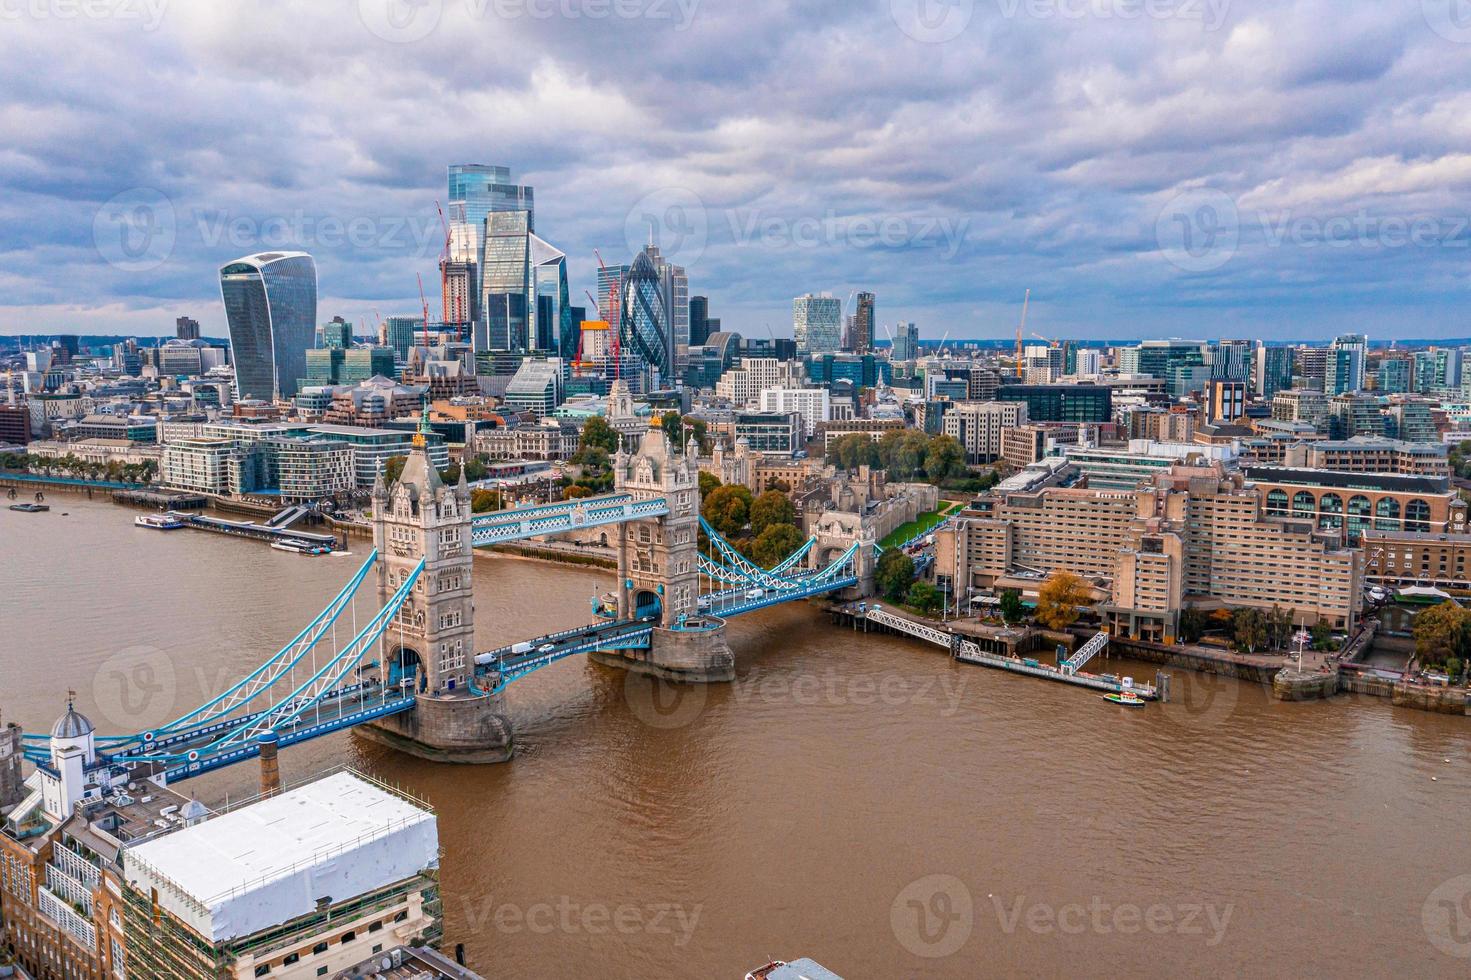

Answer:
[0,0,1471,338]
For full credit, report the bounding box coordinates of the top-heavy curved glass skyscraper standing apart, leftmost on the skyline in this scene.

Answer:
[219,252,316,400]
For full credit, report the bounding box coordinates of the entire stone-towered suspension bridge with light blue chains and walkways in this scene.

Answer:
[24,414,874,808]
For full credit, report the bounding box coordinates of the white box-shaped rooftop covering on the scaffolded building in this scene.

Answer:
[124,773,440,943]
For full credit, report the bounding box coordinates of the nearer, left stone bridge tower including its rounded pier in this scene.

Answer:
[357,413,512,762]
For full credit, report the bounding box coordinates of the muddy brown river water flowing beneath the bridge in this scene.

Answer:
[0,494,1471,980]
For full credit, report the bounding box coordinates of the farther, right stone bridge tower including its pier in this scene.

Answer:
[593,418,736,683]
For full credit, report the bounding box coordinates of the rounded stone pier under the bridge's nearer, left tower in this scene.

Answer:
[355,692,515,765]
